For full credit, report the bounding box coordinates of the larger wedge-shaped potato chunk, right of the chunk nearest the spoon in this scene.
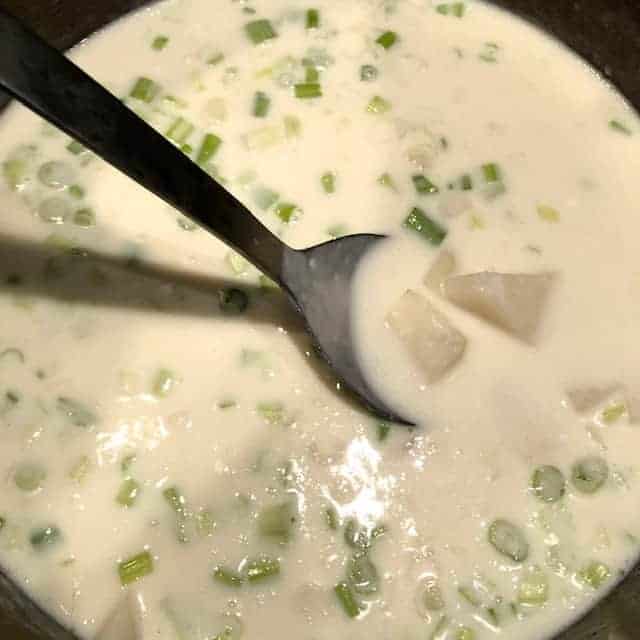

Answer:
[443,271,553,342]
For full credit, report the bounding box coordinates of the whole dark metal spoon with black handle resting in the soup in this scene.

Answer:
[0,11,411,425]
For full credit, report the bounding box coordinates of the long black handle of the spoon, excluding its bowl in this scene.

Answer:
[0,10,292,281]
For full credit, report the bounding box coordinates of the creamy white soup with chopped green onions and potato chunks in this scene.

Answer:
[0,0,640,640]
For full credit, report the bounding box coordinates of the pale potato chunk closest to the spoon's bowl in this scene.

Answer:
[387,291,467,383]
